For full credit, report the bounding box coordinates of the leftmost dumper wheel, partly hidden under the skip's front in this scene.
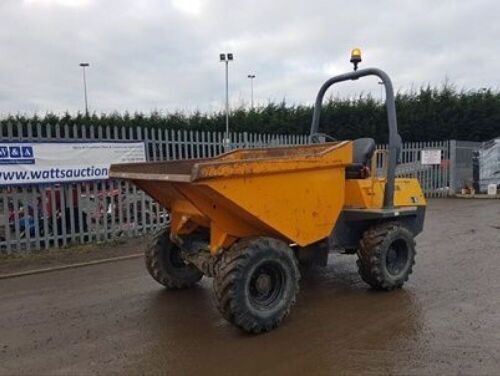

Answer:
[145,228,203,289]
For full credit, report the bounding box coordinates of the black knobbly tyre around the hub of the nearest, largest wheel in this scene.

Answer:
[213,237,300,334]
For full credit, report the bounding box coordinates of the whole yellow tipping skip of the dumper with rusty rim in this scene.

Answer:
[110,141,352,254]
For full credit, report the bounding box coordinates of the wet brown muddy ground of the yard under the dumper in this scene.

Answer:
[0,200,500,375]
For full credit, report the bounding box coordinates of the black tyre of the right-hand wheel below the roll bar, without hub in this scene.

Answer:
[356,222,417,291]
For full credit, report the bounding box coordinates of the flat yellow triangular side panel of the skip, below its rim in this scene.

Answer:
[205,166,344,246]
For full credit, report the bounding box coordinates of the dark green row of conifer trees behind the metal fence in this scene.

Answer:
[0,84,500,142]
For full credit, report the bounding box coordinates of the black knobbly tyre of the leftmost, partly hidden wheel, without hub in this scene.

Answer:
[144,229,203,290]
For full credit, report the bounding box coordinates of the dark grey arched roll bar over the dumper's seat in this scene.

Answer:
[310,68,401,208]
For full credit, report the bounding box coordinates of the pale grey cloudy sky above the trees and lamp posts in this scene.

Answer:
[0,0,500,115]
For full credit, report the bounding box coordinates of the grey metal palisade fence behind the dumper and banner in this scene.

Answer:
[0,123,468,252]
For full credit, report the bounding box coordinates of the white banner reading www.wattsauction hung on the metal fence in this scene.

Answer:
[0,142,146,185]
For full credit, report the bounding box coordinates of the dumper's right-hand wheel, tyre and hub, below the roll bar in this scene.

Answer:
[357,222,416,291]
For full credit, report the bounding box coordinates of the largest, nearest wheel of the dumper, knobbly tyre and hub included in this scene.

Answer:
[214,237,300,333]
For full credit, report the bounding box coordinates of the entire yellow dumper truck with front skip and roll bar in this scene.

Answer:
[110,57,426,333]
